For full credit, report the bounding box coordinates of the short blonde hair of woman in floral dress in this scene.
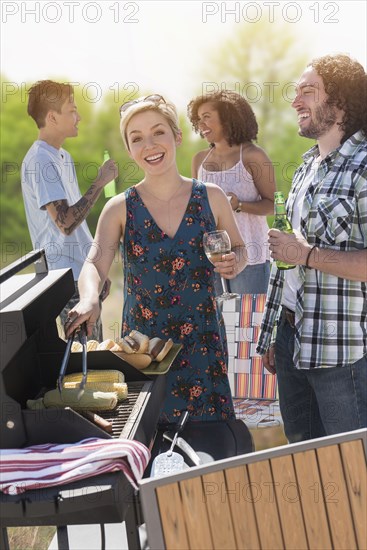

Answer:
[120,99,181,151]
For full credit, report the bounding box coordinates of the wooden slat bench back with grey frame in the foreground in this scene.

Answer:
[140,429,367,550]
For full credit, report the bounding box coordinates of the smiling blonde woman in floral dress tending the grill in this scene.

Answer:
[68,95,246,423]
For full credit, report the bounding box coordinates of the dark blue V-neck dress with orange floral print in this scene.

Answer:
[121,180,234,423]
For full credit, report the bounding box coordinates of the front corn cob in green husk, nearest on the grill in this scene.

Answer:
[43,388,117,411]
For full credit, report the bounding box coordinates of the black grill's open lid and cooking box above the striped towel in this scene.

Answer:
[0,251,165,448]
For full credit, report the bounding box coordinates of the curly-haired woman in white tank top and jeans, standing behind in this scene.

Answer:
[188,91,276,294]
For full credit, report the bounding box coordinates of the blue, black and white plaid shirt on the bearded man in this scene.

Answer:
[256,132,367,369]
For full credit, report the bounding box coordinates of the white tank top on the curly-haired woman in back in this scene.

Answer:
[198,145,270,265]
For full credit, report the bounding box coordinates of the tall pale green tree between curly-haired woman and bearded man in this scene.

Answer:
[191,19,312,201]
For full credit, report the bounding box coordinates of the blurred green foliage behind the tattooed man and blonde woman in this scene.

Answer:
[0,81,203,266]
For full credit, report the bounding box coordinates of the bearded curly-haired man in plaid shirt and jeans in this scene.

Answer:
[257,55,367,442]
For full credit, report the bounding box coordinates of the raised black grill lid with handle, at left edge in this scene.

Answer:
[0,250,74,448]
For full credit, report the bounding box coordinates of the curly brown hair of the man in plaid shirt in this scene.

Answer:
[309,54,367,143]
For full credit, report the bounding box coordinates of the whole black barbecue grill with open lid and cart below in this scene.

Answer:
[0,251,165,549]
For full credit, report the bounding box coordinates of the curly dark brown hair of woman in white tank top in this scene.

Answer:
[187,90,258,145]
